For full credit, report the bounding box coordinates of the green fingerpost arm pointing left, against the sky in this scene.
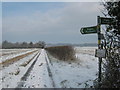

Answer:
[80,26,97,34]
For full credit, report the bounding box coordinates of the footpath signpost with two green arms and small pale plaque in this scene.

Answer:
[80,16,113,87]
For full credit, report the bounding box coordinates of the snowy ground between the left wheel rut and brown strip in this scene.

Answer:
[0,52,38,88]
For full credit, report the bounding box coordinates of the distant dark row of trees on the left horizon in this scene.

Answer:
[2,40,45,49]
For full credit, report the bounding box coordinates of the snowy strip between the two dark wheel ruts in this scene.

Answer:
[23,49,53,88]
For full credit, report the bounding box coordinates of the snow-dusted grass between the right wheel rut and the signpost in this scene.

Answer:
[49,47,98,88]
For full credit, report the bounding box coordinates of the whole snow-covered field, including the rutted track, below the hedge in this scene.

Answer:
[0,47,98,88]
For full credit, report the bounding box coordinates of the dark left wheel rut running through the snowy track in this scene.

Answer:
[15,51,41,90]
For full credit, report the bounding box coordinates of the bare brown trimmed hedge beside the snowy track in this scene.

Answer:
[45,46,75,61]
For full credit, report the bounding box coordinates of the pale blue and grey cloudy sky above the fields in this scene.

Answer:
[2,2,102,44]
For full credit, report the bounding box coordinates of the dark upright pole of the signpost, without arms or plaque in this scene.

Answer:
[97,16,102,87]
